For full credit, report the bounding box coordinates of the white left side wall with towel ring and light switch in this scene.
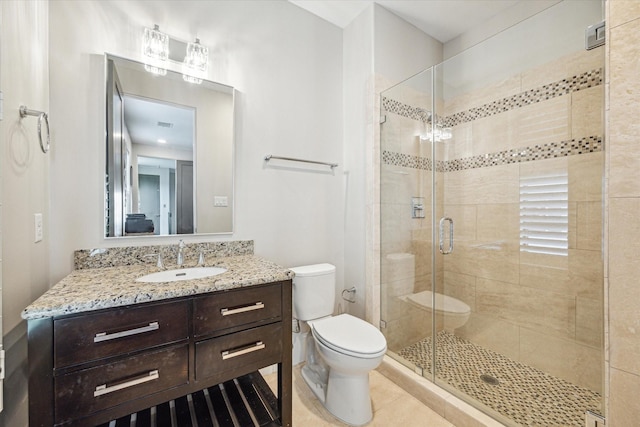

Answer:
[0,0,49,427]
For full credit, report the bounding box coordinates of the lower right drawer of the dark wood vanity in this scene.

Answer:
[196,323,282,380]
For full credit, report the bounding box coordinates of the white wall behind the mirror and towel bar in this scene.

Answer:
[50,1,344,286]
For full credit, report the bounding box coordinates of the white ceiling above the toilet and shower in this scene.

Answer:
[289,0,522,43]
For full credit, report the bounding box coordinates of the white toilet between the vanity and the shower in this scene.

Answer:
[291,264,387,426]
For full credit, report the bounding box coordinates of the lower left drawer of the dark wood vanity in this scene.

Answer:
[54,345,188,423]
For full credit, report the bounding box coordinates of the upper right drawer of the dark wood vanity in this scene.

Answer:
[193,284,282,337]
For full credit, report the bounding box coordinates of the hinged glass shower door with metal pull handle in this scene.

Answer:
[433,2,604,426]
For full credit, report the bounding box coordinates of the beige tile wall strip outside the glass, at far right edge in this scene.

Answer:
[605,0,640,427]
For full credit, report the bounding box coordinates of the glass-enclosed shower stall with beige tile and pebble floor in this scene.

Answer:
[380,0,604,426]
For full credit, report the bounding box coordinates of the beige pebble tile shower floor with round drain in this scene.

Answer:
[398,331,601,427]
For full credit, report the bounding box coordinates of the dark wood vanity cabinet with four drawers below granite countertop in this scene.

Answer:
[28,280,292,427]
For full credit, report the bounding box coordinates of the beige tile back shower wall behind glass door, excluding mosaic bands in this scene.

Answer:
[444,48,604,391]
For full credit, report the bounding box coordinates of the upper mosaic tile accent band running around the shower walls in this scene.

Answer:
[382,68,602,127]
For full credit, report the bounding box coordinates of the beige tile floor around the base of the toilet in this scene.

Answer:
[265,366,455,427]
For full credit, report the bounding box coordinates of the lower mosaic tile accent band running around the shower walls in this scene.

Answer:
[382,136,602,172]
